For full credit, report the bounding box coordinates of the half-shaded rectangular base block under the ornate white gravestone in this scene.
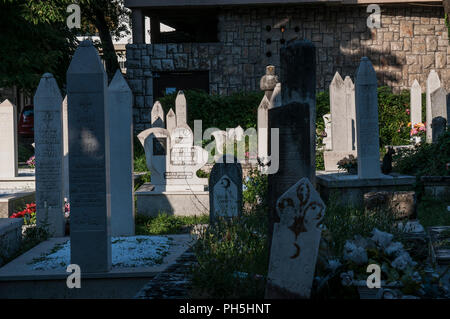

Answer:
[134,183,209,216]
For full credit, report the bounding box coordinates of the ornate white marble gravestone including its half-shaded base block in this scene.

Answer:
[135,91,209,216]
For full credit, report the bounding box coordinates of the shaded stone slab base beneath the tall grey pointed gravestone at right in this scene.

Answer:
[316,171,416,207]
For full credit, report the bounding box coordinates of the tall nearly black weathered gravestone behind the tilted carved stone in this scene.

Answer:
[268,41,316,249]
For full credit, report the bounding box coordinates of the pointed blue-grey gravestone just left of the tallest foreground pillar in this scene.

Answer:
[34,73,65,237]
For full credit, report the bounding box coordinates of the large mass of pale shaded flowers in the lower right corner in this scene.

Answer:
[314,228,449,299]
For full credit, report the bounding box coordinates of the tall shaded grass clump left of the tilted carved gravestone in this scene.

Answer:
[192,210,269,298]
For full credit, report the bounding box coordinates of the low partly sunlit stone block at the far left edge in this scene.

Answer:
[0,189,35,218]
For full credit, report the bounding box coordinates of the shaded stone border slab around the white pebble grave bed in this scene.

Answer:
[0,234,195,299]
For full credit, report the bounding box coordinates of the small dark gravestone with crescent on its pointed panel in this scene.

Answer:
[209,155,242,223]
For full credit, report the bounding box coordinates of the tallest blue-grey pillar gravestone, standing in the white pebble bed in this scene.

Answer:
[67,40,111,272]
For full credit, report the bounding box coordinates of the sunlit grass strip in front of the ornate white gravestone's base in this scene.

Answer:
[136,213,209,235]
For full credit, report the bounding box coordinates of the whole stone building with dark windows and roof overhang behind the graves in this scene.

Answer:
[125,0,450,131]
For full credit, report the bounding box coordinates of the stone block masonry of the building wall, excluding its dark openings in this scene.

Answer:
[126,5,450,131]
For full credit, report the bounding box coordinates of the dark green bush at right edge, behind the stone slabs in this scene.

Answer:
[393,130,450,176]
